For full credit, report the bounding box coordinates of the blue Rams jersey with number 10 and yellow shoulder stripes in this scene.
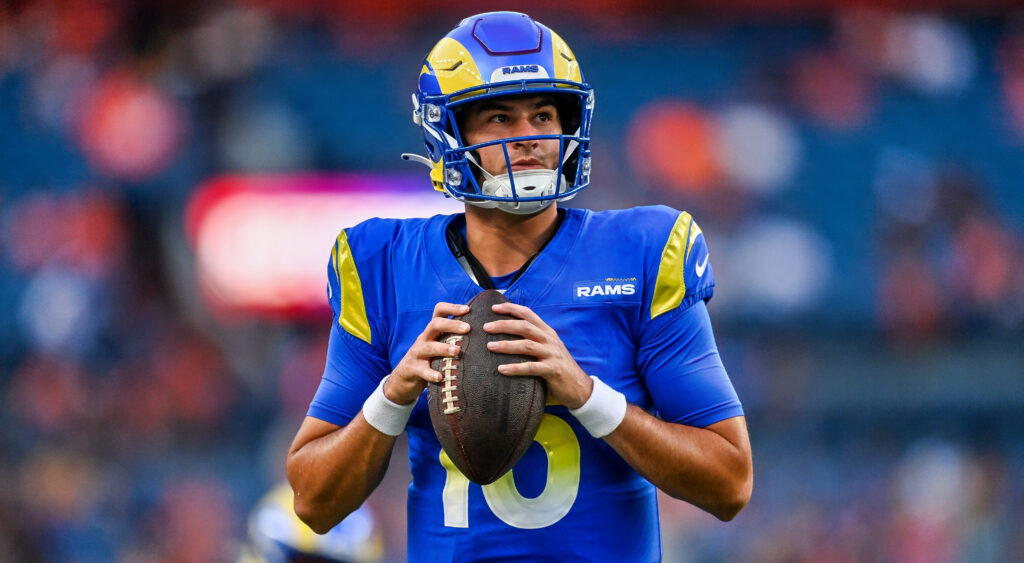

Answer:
[309,207,742,562]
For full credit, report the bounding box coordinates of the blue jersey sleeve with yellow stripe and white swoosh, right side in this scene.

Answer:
[637,208,743,427]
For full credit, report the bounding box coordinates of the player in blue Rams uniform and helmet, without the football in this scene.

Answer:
[288,12,753,561]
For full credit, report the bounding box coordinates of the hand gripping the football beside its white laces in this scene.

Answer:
[384,302,469,404]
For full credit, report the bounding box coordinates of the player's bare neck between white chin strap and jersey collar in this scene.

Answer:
[466,204,558,276]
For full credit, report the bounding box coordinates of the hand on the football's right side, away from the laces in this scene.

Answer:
[483,303,594,408]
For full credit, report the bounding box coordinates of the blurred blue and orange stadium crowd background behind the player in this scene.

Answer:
[0,0,1024,562]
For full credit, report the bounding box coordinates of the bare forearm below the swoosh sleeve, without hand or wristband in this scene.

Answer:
[605,404,754,520]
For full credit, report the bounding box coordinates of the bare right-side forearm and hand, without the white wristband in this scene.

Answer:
[484,303,754,520]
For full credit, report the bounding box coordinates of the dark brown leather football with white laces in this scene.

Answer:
[428,290,547,485]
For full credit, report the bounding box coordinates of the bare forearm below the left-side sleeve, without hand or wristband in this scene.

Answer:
[287,413,395,533]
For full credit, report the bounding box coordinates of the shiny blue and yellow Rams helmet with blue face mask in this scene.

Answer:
[402,11,594,214]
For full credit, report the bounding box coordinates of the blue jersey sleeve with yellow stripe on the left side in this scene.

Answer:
[307,230,389,426]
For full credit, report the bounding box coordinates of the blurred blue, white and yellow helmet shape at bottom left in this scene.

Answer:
[239,483,384,563]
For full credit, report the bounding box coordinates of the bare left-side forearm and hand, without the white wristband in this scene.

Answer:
[286,303,469,533]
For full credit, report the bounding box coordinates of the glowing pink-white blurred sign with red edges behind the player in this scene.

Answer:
[185,174,462,318]
